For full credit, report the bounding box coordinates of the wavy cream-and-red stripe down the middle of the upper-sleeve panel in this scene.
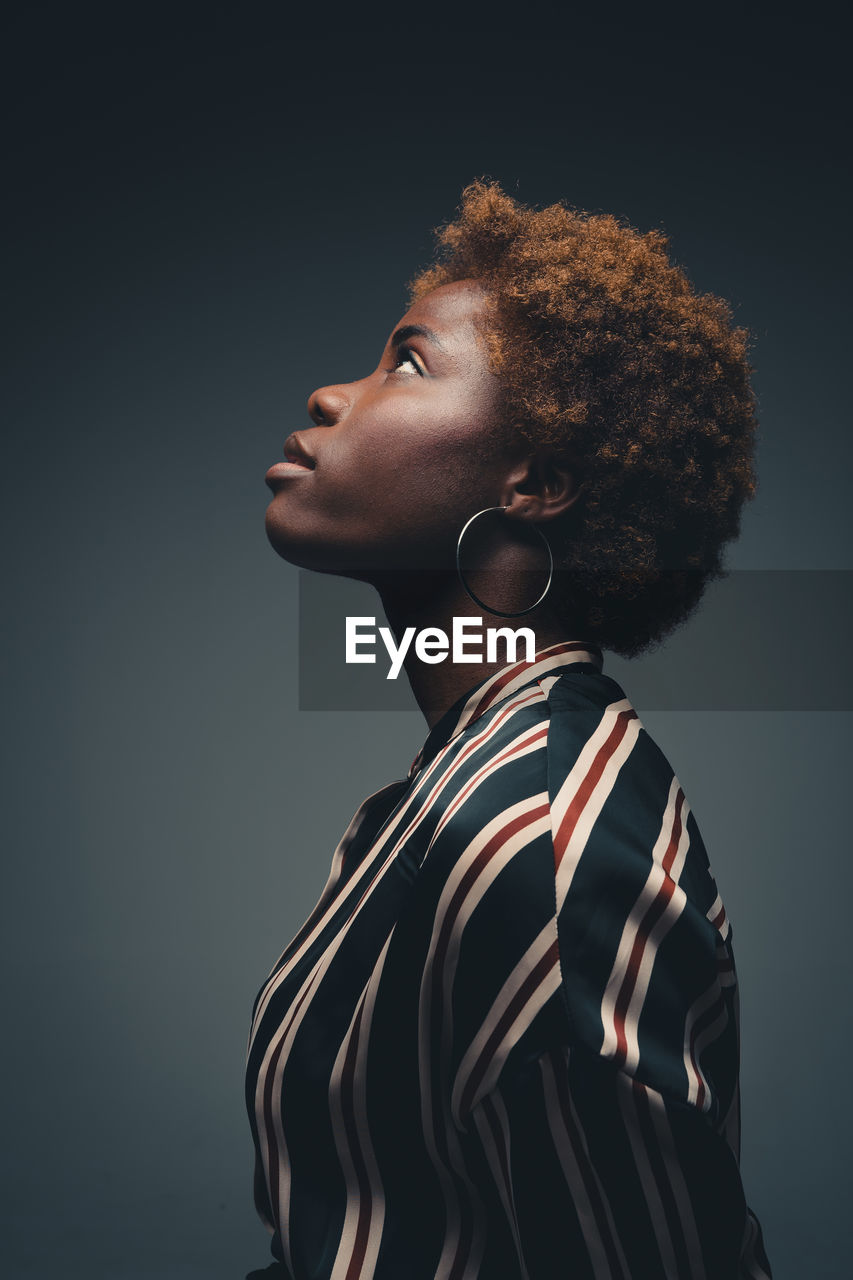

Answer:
[601,778,690,1074]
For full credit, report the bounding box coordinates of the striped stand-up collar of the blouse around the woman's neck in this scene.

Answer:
[407,640,603,778]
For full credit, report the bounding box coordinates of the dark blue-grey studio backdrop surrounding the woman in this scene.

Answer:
[0,4,853,1280]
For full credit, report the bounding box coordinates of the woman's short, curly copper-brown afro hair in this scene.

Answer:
[409,178,757,658]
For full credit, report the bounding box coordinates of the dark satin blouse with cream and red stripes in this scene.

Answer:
[246,641,770,1280]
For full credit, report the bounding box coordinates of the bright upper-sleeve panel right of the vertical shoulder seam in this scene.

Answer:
[548,676,736,1108]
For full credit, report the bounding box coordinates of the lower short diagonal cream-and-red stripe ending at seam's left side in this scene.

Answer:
[451,916,561,1128]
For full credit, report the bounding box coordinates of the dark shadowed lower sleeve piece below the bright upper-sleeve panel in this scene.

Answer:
[469,1047,770,1280]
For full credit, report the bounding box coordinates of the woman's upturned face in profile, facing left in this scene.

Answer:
[266,280,522,575]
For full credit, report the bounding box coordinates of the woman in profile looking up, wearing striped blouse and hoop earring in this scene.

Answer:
[247,182,770,1280]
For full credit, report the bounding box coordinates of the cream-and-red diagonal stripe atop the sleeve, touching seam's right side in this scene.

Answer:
[551,698,642,914]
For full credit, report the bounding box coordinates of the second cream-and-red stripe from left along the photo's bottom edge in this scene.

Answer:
[329,929,393,1280]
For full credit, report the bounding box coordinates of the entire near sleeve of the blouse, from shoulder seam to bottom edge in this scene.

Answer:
[462,687,770,1280]
